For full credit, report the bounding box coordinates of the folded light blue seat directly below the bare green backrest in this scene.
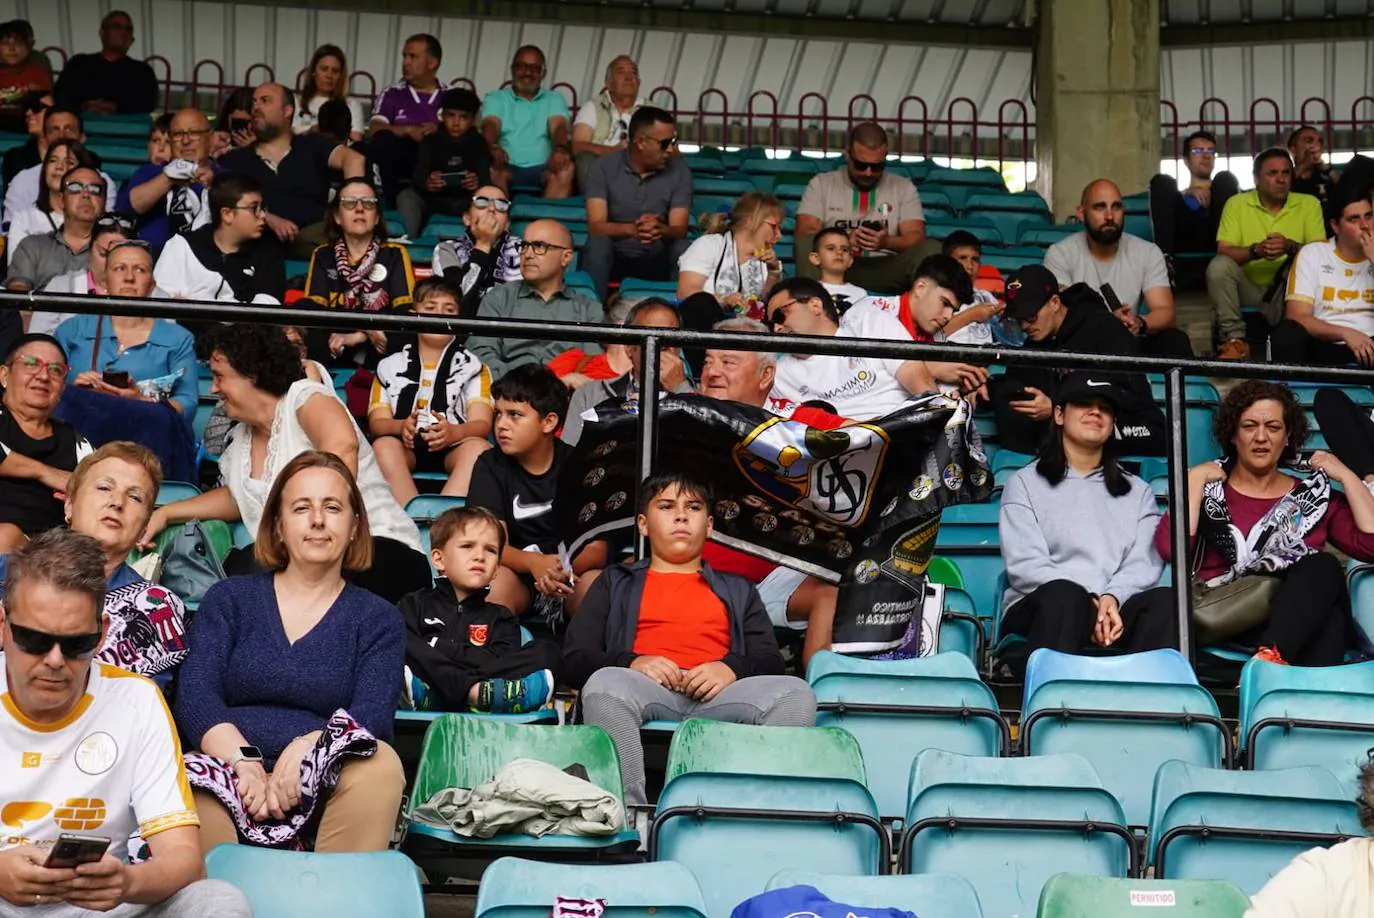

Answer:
[649,772,890,918]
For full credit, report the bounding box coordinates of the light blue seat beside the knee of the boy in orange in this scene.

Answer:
[807,650,1011,819]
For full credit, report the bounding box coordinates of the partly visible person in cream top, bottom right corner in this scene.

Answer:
[1245,759,1374,918]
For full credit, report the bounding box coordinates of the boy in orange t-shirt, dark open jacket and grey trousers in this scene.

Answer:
[563,474,816,807]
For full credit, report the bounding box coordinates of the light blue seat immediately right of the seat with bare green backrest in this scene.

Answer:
[897,749,1135,917]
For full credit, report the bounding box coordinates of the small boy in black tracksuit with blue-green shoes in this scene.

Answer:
[400,507,559,715]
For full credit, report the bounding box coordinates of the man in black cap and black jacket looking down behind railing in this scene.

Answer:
[991,265,1168,456]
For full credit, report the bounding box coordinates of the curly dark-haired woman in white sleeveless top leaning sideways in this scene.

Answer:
[143,326,430,602]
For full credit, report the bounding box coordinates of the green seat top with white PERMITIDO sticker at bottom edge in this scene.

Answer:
[1036,874,1250,918]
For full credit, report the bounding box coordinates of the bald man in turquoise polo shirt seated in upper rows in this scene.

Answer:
[481,44,576,198]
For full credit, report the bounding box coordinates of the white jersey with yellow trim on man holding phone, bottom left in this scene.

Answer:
[0,656,199,856]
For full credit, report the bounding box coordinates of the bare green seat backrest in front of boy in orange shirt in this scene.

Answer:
[664,717,866,785]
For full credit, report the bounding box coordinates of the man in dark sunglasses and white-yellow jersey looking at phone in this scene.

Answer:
[0,529,253,918]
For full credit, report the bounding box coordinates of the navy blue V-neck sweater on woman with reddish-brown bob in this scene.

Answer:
[176,574,405,767]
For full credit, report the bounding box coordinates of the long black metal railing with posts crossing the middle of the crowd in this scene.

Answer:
[10,291,1374,658]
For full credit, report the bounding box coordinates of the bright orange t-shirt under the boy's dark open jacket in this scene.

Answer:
[635,570,730,669]
